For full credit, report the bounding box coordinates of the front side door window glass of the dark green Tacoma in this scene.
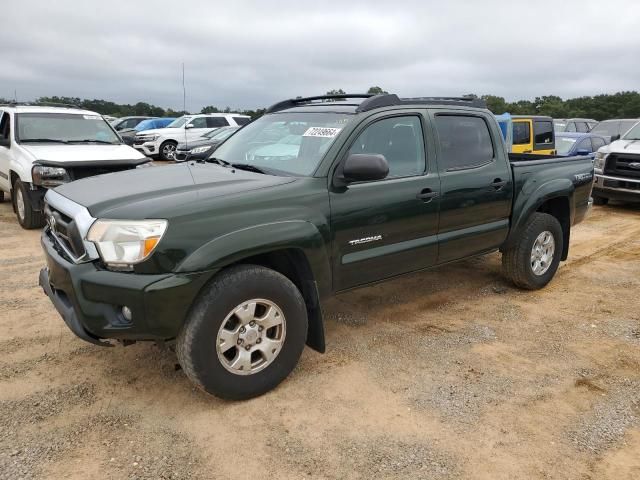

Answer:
[349,116,425,178]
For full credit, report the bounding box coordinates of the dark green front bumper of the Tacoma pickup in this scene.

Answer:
[39,229,210,345]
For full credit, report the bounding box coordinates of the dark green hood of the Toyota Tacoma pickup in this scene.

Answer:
[56,163,294,219]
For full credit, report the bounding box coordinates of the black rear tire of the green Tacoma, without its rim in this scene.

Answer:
[502,212,564,290]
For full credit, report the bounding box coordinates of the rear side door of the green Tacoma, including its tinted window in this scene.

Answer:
[432,111,513,263]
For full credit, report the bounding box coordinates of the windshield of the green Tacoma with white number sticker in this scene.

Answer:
[214,113,350,176]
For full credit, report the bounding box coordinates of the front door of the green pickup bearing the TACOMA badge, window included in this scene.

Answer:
[329,110,440,290]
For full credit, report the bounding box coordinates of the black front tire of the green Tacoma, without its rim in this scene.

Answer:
[176,265,307,400]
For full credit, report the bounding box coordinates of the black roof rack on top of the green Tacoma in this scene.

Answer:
[266,93,487,113]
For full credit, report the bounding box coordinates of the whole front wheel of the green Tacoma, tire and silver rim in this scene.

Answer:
[176,265,307,400]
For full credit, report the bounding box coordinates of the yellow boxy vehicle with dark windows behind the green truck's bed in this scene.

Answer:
[511,115,556,155]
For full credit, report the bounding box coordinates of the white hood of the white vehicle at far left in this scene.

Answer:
[20,143,144,163]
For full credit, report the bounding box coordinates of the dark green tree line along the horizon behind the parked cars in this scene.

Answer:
[0,86,640,120]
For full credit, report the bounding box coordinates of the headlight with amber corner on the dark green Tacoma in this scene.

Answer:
[87,220,167,269]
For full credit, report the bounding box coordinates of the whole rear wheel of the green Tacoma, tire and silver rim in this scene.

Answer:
[502,212,564,290]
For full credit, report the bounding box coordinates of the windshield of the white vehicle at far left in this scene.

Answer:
[16,113,121,144]
